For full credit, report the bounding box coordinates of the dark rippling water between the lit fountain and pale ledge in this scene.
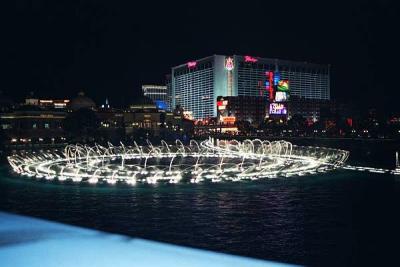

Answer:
[0,166,400,266]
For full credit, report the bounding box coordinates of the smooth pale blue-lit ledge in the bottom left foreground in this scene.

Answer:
[0,212,289,267]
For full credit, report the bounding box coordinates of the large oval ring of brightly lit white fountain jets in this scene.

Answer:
[8,139,349,185]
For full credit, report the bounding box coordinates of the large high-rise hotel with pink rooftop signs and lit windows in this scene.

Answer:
[171,55,330,119]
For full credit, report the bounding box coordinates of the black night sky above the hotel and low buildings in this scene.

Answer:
[0,0,400,109]
